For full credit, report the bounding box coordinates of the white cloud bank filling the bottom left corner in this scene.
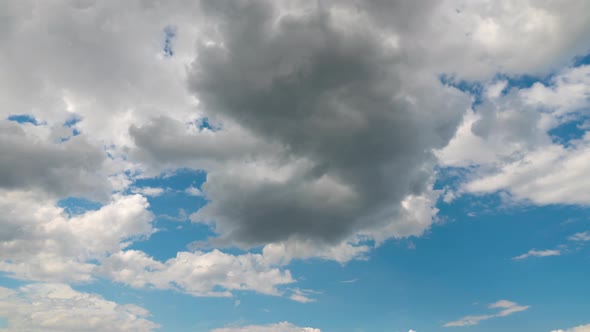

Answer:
[0,284,159,332]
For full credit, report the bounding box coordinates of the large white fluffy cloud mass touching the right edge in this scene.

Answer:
[437,66,590,205]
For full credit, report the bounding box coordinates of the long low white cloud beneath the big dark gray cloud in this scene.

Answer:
[98,250,303,302]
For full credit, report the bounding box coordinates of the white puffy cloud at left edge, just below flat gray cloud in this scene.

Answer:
[0,191,154,281]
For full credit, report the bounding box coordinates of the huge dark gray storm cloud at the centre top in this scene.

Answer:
[130,1,469,245]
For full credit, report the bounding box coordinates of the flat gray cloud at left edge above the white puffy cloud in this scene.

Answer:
[0,121,108,198]
